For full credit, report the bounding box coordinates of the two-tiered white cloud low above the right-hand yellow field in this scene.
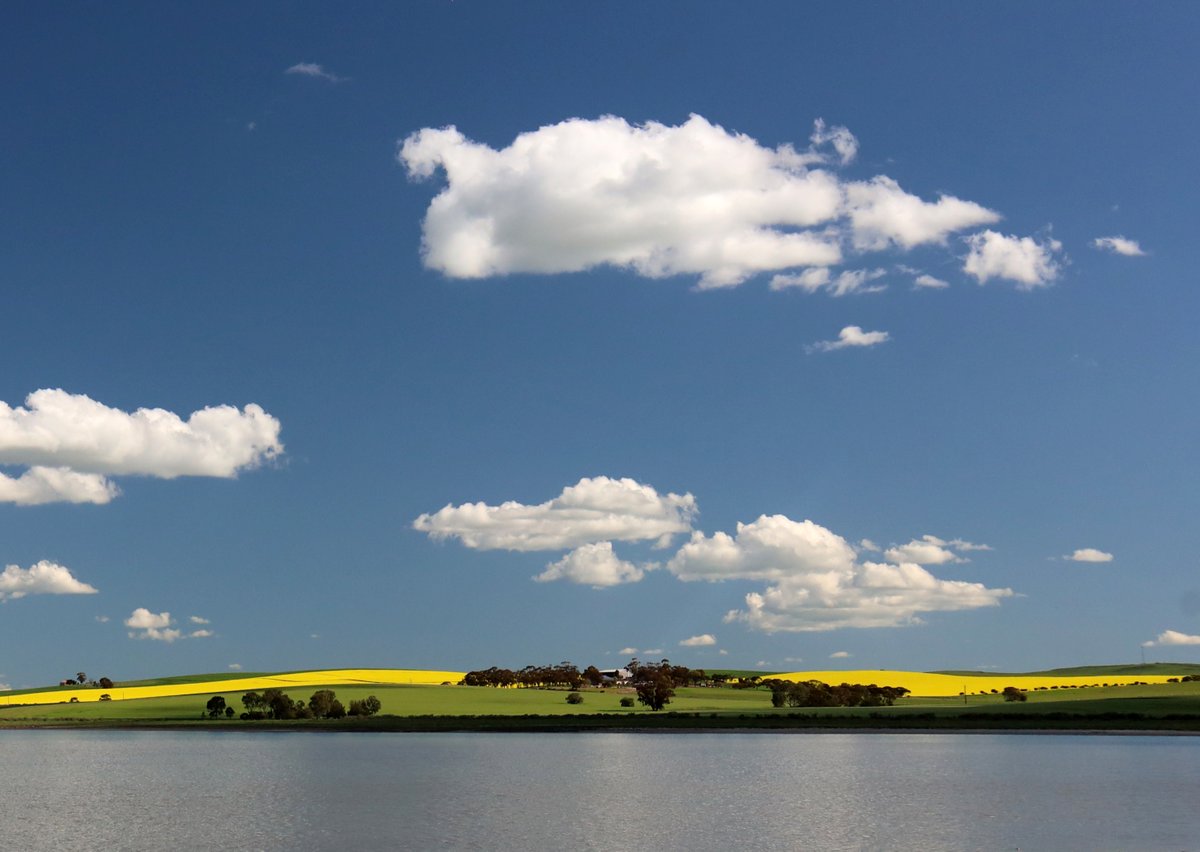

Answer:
[667,515,1013,632]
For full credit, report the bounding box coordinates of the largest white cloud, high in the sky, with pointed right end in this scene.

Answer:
[397,115,998,288]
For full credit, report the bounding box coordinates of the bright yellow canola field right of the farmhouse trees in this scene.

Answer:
[770,670,1168,696]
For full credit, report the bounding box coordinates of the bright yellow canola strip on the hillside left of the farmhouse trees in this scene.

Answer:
[0,668,463,707]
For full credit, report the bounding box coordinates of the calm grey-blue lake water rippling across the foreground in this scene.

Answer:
[0,731,1200,851]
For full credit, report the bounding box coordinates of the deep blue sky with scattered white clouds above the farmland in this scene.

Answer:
[0,1,1200,686]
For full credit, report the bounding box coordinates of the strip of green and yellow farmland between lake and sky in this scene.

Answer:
[0,665,1200,732]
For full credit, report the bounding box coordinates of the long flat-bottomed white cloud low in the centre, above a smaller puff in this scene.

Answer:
[413,476,696,551]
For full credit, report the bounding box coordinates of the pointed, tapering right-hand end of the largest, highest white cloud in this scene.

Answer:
[846,175,1000,251]
